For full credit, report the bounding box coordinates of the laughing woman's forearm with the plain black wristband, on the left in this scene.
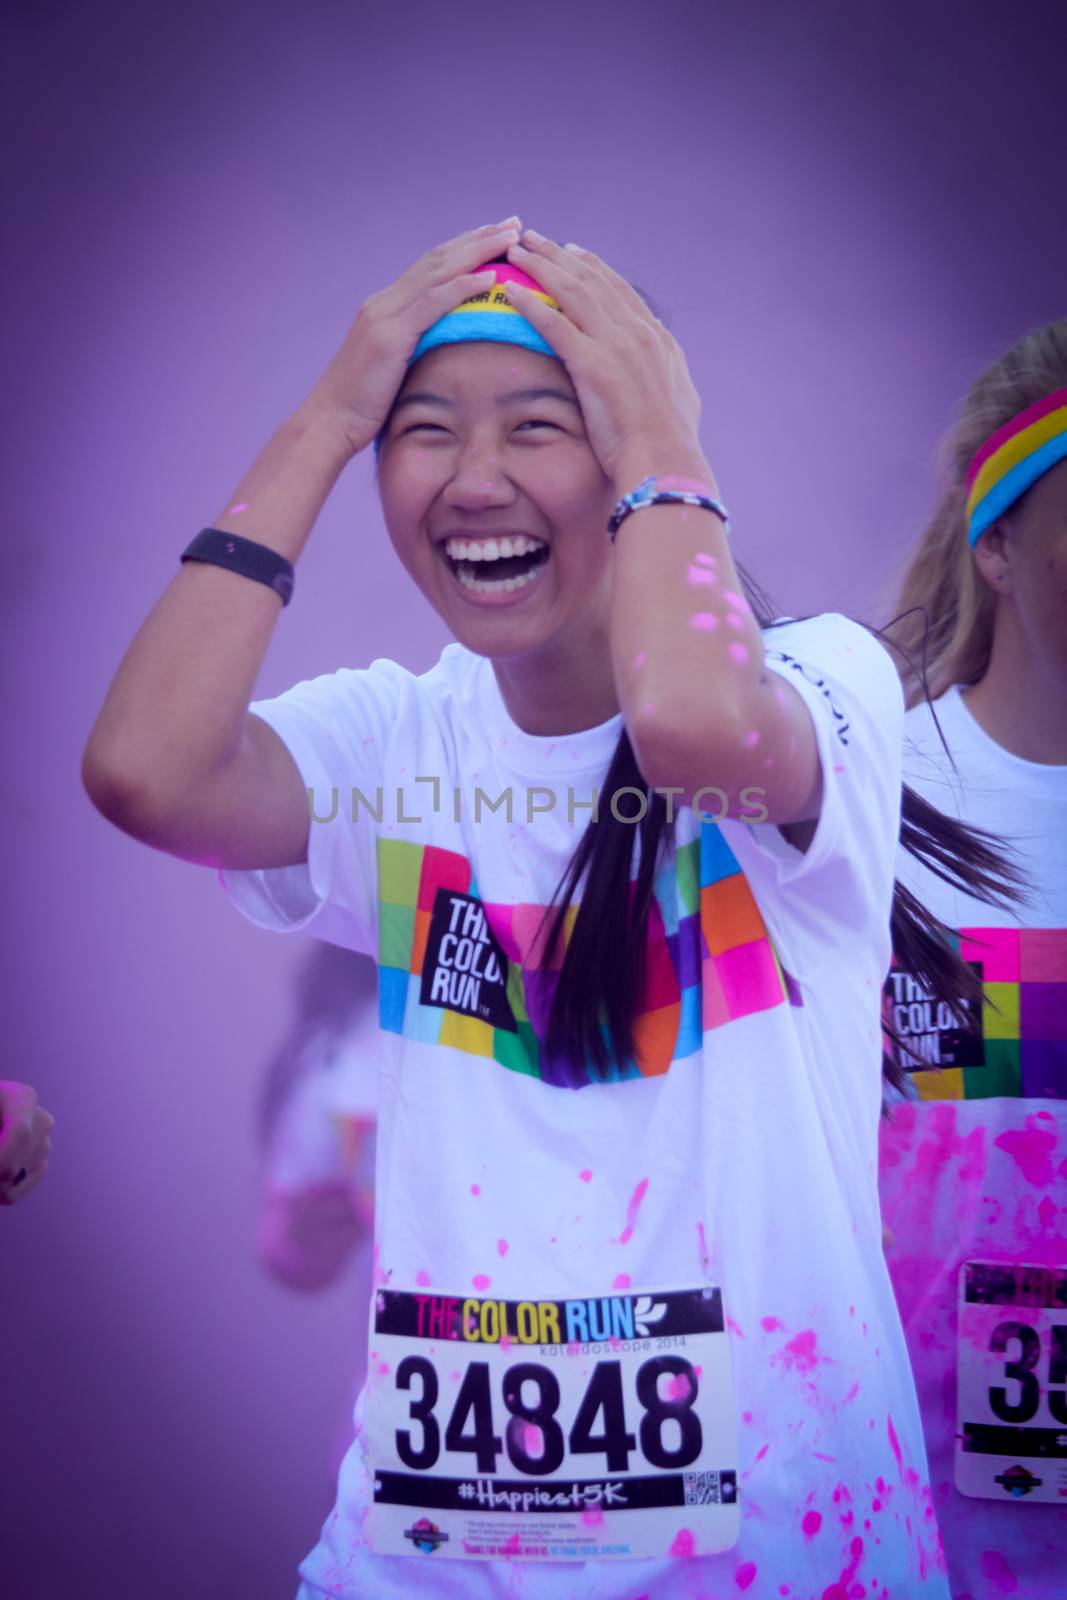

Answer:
[85,403,350,812]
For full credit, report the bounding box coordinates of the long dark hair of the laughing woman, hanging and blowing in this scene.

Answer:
[545,566,1024,1093]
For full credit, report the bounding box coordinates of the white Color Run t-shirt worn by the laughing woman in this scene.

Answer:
[226,614,947,1600]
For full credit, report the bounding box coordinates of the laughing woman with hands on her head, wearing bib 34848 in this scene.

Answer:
[77,218,1017,1600]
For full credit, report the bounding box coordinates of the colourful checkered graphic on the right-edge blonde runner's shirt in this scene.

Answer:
[885,928,1067,1099]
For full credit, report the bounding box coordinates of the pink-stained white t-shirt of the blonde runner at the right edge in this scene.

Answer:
[881,688,1067,1600]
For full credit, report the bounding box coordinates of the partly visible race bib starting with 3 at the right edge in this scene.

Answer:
[955,1261,1067,1506]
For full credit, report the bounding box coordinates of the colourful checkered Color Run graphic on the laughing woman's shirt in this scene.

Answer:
[378,821,803,1088]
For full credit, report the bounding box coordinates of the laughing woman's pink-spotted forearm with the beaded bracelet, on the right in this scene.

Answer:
[611,440,763,787]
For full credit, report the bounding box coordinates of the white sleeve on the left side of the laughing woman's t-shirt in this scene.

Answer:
[219,661,414,958]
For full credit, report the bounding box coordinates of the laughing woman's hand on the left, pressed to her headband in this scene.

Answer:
[307,216,522,454]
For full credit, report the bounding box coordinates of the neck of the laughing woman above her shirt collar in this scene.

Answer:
[493,634,619,736]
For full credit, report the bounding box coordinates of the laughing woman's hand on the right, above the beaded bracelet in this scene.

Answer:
[507,229,701,478]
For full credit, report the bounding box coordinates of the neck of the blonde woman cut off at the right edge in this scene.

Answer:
[961,602,1067,766]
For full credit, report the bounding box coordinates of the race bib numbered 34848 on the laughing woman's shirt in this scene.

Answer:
[366,1288,741,1562]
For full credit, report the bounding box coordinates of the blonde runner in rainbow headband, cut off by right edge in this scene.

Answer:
[880,322,1067,1600]
